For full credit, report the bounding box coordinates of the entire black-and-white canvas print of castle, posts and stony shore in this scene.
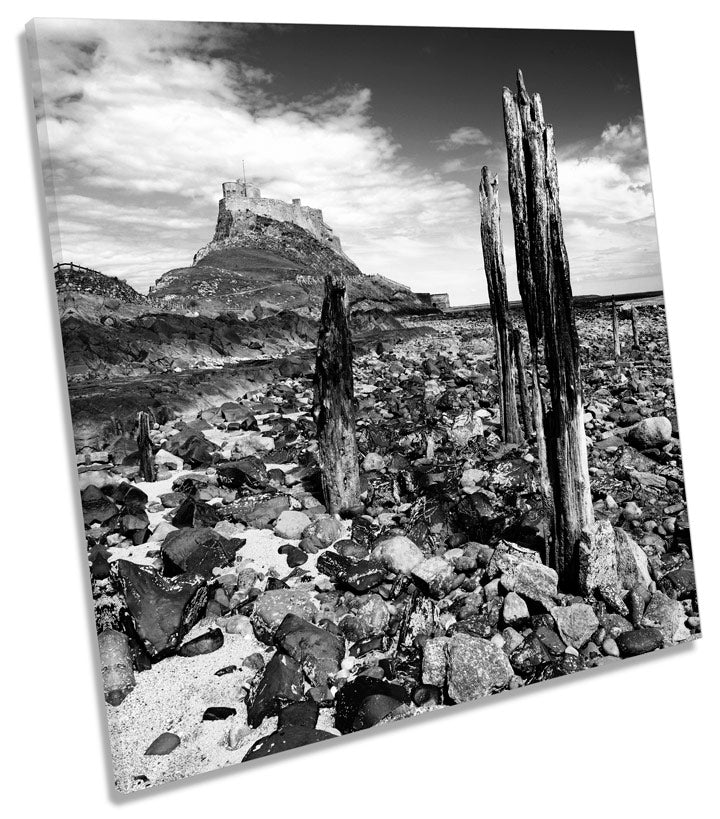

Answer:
[28,20,700,792]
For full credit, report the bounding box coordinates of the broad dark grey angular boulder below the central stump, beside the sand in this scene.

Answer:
[274,614,345,686]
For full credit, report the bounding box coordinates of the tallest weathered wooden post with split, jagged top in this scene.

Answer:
[503,71,594,584]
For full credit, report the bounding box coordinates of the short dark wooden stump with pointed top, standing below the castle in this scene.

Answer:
[315,273,360,514]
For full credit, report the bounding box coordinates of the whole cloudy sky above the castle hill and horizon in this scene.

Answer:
[29,19,662,304]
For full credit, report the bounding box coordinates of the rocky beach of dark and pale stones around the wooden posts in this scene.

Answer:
[77,304,700,791]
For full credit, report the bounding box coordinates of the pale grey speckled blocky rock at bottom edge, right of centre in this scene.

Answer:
[447,634,513,702]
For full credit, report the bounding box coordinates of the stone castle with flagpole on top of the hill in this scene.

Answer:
[220,179,345,255]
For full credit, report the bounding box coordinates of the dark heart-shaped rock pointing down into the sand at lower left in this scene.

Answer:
[117,560,207,657]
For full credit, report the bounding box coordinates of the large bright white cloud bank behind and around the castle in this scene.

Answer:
[31,21,475,289]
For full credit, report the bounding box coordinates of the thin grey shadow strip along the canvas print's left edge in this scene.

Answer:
[17,31,126,804]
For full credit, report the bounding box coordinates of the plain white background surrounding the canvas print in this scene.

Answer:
[0,0,720,819]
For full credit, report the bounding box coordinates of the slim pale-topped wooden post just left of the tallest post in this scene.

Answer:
[480,165,522,444]
